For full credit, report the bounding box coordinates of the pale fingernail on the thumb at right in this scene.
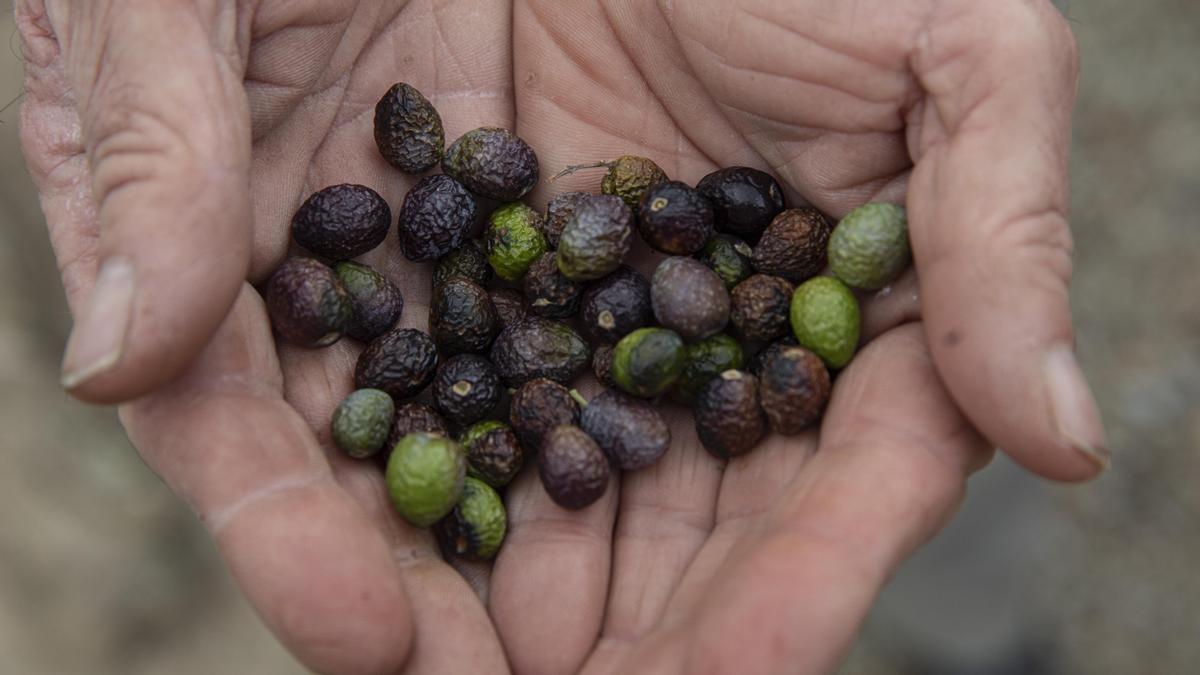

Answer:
[1044,345,1112,470]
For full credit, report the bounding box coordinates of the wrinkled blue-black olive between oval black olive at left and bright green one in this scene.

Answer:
[396,174,475,261]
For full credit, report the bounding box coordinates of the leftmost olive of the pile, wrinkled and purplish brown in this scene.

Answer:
[266,257,354,347]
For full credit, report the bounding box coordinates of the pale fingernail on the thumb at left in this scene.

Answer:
[62,257,134,389]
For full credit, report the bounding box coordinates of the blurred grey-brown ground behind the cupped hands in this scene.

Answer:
[0,0,1200,675]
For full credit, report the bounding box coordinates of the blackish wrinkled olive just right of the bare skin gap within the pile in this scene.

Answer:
[430,276,499,356]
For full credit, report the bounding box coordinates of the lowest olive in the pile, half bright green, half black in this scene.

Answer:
[437,477,508,561]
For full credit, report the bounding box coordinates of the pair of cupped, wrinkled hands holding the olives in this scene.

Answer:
[16,0,1104,674]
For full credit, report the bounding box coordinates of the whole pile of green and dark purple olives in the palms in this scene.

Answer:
[265,83,911,558]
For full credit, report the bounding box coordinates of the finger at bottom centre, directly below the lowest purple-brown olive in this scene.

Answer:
[490,456,618,674]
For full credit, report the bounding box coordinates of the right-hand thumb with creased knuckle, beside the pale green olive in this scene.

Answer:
[908,1,1109,480]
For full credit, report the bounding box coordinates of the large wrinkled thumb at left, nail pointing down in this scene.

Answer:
[22,0,251,402]
